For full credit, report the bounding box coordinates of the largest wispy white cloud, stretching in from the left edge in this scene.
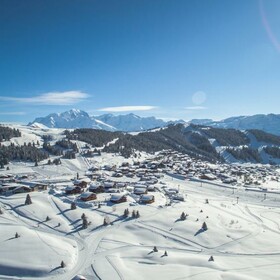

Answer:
[0,91,89,105]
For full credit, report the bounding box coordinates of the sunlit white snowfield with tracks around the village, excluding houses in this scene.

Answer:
[0,128,280,280]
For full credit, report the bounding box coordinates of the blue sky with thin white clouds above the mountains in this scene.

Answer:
[0,0,280,122]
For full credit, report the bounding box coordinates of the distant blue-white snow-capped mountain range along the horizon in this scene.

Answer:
[29,109,280,135]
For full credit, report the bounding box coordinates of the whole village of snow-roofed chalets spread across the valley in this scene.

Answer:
[0,150,280,201]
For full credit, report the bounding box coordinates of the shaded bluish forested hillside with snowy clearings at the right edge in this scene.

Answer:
[185,124,280,164]
